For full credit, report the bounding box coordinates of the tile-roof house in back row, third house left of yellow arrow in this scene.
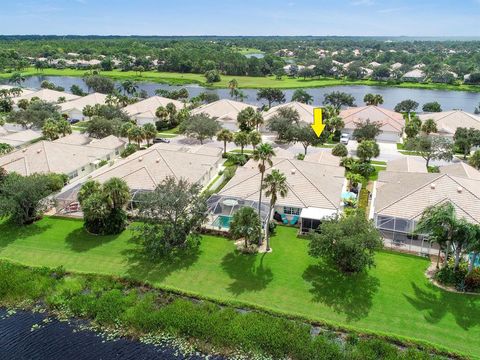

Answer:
[123,96,185,126]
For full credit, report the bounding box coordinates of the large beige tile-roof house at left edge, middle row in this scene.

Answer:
[0,139,125,179]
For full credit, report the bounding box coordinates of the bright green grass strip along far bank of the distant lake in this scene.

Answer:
[0,68,480,92]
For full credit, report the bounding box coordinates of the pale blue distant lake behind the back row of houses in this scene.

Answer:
[3,76,480,112]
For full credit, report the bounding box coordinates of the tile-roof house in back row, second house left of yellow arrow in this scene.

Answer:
[191,99,256,131]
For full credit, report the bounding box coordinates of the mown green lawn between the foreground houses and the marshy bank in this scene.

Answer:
[0,218,480,357]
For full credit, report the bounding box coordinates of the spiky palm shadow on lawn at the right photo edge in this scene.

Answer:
[405,283,480,330]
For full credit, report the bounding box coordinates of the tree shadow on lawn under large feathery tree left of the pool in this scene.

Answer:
[122,247,201,282]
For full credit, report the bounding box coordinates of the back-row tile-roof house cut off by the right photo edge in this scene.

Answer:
[419,110,480,136]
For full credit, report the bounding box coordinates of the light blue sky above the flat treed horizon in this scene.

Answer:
[0,0,480,36]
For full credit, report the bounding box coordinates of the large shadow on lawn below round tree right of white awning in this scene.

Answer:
[303,263,379,322]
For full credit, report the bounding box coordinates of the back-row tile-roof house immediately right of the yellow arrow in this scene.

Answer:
[340,105,405,142]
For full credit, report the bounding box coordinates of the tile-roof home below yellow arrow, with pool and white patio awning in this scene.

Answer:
[206,157,347,233]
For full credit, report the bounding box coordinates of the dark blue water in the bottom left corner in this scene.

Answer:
[0,309,221,360]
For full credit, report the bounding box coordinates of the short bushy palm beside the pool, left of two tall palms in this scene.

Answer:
[229,207,262,249]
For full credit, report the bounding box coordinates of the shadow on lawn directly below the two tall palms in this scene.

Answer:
[222,250,273,295]
